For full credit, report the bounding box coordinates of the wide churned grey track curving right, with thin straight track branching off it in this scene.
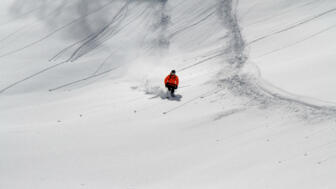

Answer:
[214,0,336,119]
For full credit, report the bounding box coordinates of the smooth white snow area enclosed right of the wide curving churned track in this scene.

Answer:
[240,0,336,102]
